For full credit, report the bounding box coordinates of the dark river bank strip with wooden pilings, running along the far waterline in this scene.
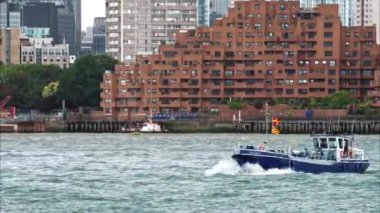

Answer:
[0,119,380,134]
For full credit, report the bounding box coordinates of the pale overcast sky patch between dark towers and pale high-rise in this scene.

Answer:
[82,0,106,30]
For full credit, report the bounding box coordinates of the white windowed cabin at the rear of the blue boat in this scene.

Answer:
[310,135,364,160]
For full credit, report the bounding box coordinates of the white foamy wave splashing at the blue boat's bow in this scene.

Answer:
[204,160,293,177]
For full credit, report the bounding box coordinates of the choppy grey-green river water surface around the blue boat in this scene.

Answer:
[0,134,380,213]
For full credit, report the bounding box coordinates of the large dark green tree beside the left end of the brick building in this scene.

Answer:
[58,55,118,107]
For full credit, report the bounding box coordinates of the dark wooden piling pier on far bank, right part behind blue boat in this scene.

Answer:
[233,120,380,134]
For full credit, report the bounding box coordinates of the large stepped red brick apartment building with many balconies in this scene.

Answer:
[100,0,380,118]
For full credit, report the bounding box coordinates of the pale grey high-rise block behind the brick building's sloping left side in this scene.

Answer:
[106,0,197,64]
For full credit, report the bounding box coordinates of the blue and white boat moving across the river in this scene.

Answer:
[232,134,370,174]
